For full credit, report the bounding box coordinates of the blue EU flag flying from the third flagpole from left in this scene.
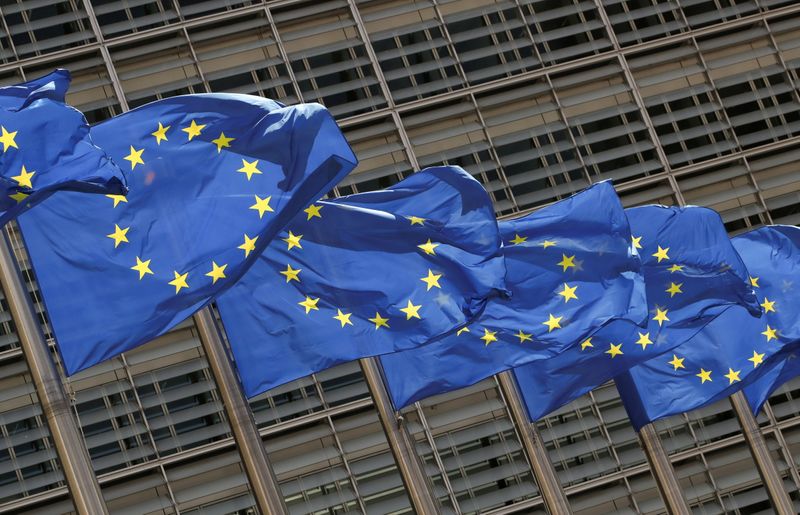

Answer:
[381,182,647,409]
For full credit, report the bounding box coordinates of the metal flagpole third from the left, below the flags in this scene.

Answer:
[359,358,440,515]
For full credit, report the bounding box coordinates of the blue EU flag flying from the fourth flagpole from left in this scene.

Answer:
[515,206,760,420]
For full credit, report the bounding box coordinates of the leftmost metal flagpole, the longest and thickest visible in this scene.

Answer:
[0,231,108,515]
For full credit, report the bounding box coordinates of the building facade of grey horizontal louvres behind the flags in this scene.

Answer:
[0,0,800,515]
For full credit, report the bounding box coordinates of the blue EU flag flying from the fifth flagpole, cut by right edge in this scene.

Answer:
[615,226,800,430]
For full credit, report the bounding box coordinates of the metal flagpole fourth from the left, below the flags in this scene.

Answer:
[496,371,572,515]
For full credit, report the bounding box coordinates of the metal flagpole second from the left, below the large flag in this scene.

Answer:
[193,307,289,515]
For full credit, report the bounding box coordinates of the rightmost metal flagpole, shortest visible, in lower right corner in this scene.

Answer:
[730,391,795,515]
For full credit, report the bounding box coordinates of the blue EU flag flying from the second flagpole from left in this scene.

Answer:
[217,167,505,396]
